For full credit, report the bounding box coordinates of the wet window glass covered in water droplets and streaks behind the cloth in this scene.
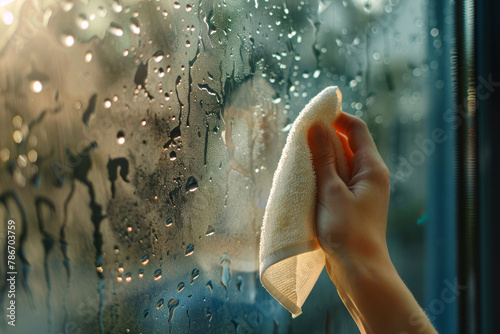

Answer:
[0,0,434,333]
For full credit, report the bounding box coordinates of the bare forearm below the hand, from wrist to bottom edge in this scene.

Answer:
[327,249,436,333]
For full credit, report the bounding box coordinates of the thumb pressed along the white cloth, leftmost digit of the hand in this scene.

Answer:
[307,123,342,190]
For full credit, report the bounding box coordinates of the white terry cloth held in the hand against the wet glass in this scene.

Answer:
[259,87,349,317]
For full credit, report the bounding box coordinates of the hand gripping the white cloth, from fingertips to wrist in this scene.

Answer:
[308,112,390,276]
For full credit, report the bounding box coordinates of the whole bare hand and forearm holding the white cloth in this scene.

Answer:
[308,112,436,334]
